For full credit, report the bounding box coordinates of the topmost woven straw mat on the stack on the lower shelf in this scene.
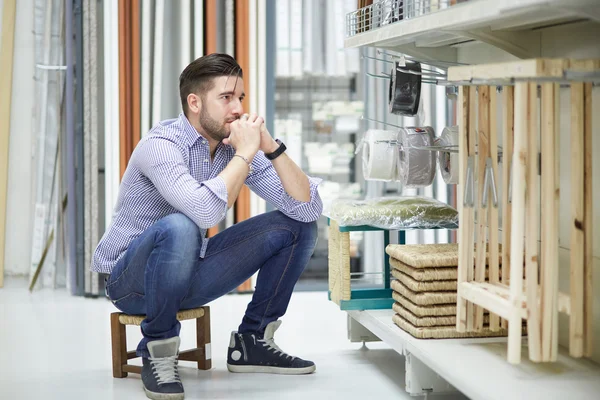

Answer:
[385,243,502,268]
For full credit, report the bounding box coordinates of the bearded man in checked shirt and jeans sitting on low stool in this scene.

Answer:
[92,54,322,399]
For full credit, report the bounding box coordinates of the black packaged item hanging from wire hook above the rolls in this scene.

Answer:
[389,60,421,117]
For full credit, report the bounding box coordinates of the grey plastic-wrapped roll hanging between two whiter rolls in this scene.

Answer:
[397,126,437,187]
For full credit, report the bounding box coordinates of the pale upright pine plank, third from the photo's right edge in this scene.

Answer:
[540,83,560,361]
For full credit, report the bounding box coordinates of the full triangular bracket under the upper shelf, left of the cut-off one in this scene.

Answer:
[450,28,542,59]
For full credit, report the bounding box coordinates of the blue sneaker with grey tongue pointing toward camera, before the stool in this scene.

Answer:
[142,336,184,400]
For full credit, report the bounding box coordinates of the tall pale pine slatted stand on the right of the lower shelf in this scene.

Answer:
[448,59,600,364]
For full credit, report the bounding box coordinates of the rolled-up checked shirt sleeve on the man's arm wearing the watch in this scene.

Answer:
[246,152,323,222]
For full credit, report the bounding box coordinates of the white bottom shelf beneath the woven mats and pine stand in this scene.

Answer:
[348,310,600,400]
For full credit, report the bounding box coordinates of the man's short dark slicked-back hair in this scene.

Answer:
[179,53,243,115]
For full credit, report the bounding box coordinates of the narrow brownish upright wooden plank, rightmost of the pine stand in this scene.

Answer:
[583,83,594,357]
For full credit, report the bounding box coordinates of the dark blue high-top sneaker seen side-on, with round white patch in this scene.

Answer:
[227,321,316,375]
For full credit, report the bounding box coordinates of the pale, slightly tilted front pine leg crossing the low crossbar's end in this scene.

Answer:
[503,82,529,364]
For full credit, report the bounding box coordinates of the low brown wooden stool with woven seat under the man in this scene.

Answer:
[110,306,212,378]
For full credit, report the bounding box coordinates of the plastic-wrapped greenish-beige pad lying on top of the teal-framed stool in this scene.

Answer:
[327,196,458,230]
